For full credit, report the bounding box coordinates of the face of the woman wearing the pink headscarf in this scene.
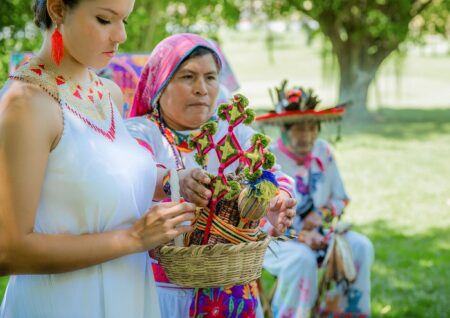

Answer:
[159,54,219,130]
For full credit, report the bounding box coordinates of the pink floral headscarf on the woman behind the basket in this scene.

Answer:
[128,33,222,117]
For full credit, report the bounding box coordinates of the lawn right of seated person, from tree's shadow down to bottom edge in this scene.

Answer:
[258,109,450,318]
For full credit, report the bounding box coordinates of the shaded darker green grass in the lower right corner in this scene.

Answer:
[262,221,450,318]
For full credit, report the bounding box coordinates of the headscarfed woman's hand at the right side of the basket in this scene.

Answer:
[266,191,297,233]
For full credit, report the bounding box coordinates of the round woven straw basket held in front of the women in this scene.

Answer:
[157,238,270,288]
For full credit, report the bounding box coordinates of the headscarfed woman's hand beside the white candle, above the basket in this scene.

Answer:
[178,168,212,207]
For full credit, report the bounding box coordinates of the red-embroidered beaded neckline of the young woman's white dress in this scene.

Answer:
[10,58,116,141]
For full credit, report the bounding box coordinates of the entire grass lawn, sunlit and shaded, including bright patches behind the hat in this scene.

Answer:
[0,28,450,318]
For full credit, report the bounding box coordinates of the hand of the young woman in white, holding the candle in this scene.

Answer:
[130,202,196,252]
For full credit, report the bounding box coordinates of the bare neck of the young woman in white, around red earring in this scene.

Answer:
[36,32,91,83]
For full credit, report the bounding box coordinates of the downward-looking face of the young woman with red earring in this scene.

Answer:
[60,0,134,68]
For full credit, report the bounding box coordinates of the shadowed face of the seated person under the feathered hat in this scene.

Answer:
[286,121,319,156]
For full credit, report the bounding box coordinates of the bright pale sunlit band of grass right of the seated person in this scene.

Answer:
[335,110,450,233]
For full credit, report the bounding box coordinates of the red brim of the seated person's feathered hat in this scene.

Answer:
[256,107,345,125]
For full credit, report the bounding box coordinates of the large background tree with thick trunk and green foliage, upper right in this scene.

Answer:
[258,0,450,118]
